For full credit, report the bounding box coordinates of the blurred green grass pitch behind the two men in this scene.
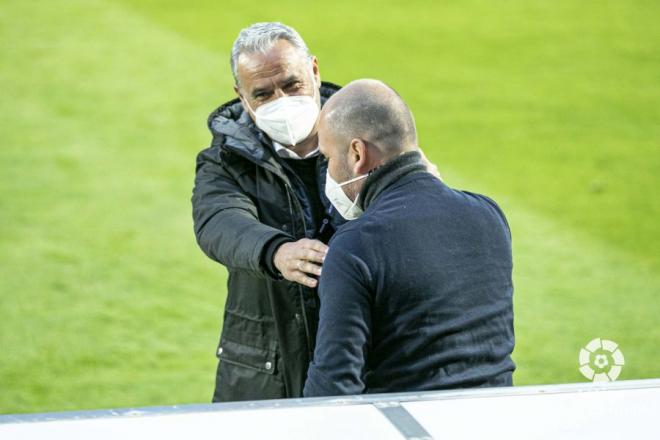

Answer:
[0,0,660,413]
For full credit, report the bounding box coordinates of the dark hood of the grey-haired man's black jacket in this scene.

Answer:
[208,81,340,162]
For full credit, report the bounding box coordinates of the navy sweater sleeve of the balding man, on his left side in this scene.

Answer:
[303,234,372,397]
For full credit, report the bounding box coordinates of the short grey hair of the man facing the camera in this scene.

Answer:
[230,21,312,84]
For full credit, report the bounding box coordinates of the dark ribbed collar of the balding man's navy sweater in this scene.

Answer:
[358,151,426,211]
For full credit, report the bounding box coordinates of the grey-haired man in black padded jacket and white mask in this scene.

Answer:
[192,23,343,402]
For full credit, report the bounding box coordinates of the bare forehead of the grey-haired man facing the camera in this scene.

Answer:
[237,40,307,83]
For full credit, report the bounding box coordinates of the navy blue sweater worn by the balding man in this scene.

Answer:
[304,152,515,397]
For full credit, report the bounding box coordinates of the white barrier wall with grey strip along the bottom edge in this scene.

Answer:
[0,379,660,440]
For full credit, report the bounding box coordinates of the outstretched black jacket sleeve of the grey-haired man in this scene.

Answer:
[192,147,290,277]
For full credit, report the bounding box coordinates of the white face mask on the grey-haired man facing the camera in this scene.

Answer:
[248,93,320,146]
